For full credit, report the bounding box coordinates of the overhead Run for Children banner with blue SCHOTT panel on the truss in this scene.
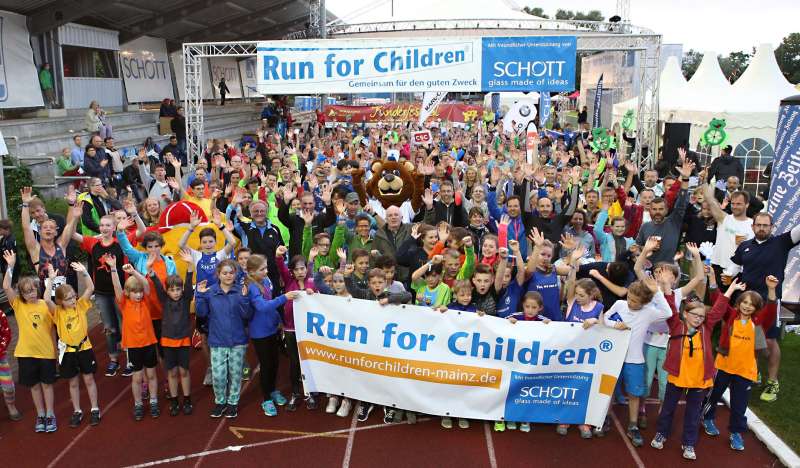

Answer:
[256,36,577,94]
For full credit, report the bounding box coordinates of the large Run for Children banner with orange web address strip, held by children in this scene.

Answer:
[294,294,630,426]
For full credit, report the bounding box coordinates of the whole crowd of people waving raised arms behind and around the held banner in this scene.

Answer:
[0,111,800,459]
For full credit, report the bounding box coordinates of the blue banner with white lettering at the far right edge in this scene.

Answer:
[767,96,800,303]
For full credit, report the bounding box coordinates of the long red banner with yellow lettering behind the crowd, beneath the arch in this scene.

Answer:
[325,104,483,123]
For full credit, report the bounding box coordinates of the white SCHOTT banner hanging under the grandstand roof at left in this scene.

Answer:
[119,36,174,102]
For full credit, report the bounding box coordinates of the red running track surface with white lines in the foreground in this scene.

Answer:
[0,328,780,468]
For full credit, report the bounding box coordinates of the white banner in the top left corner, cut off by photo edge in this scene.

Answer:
[0,11,43,109]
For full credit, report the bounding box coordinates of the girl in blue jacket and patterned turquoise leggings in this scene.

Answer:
[195,259,252,418]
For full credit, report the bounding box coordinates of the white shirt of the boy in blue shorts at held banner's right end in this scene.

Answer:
[604,291,672,364]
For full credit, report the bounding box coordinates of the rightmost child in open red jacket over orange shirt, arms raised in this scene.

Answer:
[703,275,778,450]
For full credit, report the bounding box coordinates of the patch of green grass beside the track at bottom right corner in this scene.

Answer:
[750,333,800,453]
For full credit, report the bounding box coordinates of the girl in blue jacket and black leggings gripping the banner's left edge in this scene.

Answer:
[245,255,300,416]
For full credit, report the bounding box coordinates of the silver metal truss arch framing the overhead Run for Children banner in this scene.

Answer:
[183,18,661,169]
